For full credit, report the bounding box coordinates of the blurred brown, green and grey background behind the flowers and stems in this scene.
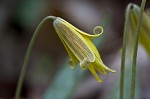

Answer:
[0,0,150,99]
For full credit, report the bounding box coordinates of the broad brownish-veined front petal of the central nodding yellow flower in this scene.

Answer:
[53,18,95,68]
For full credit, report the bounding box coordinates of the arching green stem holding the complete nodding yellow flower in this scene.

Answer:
[15,16,56,99]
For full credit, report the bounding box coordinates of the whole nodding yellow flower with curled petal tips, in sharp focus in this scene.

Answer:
[53,17,115,82]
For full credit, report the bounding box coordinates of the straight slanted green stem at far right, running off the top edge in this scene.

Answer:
[131,0,146,99]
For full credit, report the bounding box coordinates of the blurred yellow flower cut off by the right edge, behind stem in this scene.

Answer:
[129,4,150,55]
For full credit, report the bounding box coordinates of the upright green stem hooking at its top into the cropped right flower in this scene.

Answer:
[119,4,131,99]
